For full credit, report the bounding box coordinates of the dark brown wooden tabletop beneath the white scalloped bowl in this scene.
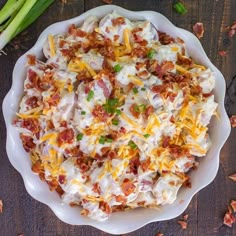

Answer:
[0,0,236,236]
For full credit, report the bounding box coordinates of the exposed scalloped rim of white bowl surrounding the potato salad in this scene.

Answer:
[3,5,230,234]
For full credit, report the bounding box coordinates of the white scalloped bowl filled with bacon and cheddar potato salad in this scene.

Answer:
[3,5,230,234]
